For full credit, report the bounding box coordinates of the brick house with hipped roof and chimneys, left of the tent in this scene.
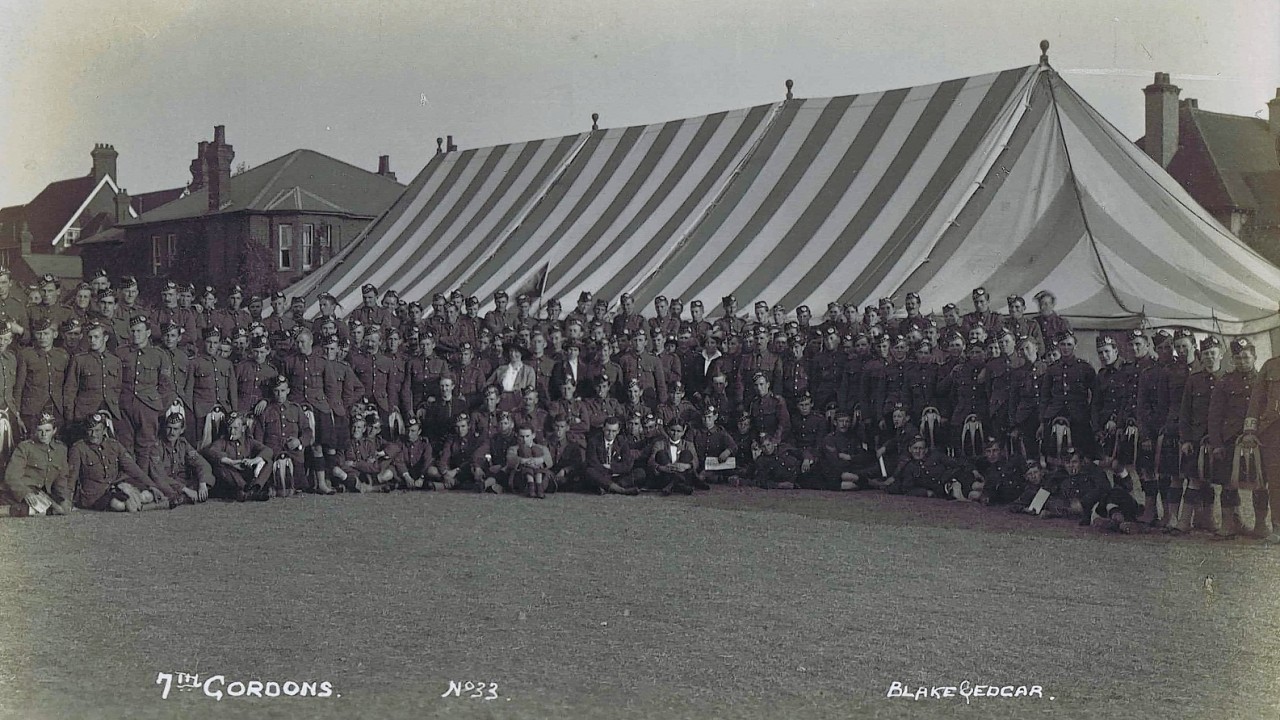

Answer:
[81,126,404,297]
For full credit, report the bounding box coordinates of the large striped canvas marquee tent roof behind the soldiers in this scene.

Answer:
[291,59,1280,334]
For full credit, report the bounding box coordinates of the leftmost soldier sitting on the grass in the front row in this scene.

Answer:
[0,413,73,518]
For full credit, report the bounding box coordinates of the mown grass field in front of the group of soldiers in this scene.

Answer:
[0,488,1280,719]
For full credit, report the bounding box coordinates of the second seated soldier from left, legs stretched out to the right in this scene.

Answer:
[67,413,187,512]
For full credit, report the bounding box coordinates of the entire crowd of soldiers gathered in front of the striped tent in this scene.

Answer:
[0,270,1280,541]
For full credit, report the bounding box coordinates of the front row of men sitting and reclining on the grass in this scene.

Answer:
[3,378,1226,532]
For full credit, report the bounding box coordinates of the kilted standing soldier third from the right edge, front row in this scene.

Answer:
[1176,336,1224,532]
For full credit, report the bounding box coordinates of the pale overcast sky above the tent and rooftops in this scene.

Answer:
[0,0,1280,205]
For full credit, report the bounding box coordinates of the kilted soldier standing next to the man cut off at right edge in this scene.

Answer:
[1208,337,1270,539]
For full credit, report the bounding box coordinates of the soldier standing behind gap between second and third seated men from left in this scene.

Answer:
[115,315,173,470]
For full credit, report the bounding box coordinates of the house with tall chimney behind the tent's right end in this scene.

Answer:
[1138,73,1280,264]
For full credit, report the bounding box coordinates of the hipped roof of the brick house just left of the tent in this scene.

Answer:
[124,150,404,227]
